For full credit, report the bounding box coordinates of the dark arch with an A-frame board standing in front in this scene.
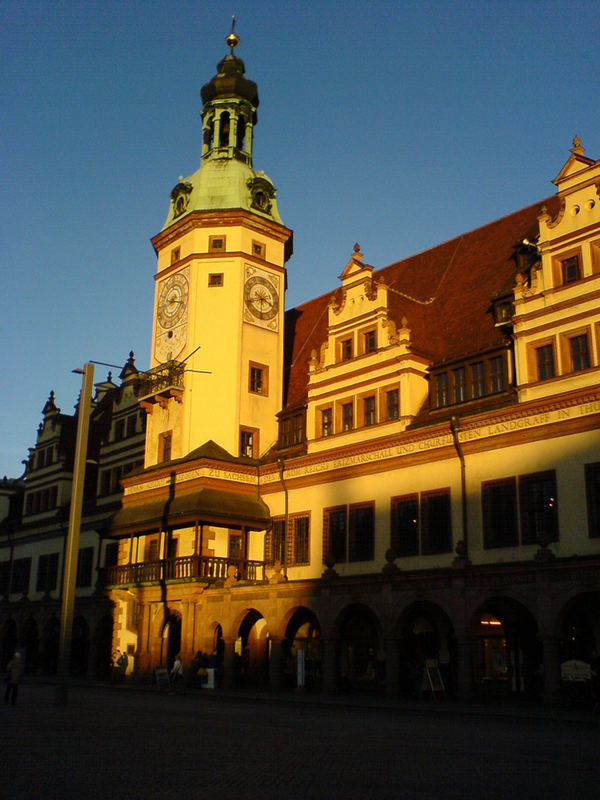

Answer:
[397,602,456,697]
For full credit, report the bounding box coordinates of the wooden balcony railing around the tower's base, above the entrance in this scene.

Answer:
[100,556,265,589]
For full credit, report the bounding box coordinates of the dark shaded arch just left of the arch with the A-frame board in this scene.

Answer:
[337,605,384,691]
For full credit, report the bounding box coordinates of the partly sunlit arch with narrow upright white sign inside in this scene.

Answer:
[283,608,322,690]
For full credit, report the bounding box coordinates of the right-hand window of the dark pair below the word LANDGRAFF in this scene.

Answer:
[519,470,558,544]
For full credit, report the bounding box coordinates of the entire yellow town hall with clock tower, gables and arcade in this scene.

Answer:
[0,34,600,703]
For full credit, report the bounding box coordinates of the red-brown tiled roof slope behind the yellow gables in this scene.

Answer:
[284,195,558,408]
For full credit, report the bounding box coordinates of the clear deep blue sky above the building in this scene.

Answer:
[0,0,600,477]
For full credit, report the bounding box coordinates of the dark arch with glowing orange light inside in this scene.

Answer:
[473,597,542,699]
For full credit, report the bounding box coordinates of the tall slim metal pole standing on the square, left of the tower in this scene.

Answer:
[55,364,94,705]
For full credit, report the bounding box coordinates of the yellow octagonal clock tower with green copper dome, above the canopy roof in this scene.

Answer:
[142,29,292,466]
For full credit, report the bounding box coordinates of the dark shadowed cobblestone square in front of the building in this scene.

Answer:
[0,684,600,800]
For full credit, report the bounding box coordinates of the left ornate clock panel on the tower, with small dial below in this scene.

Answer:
[154,269,189,363]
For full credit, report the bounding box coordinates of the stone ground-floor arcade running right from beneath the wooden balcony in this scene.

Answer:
[108,584,600,702]
